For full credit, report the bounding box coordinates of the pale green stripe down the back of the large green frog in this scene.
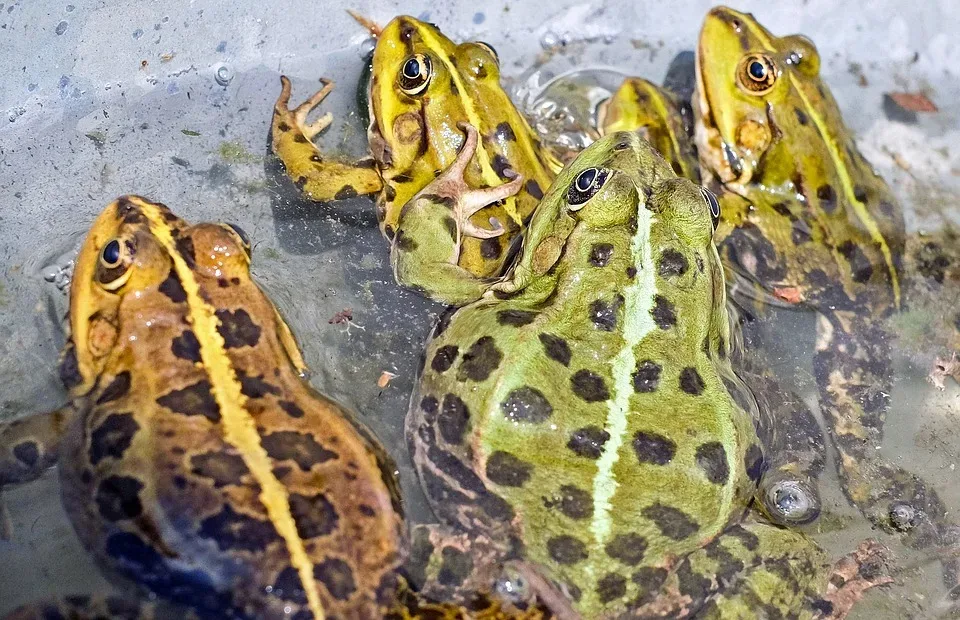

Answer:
[590,194,657,546]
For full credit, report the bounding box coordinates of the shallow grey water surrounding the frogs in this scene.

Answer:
[0,0,960,618]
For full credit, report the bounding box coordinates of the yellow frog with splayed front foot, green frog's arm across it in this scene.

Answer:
[271,16,561,304]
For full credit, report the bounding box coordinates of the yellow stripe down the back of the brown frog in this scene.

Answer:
[137,201,325,620]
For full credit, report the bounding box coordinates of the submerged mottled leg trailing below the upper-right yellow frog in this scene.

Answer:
[814,313,955,556]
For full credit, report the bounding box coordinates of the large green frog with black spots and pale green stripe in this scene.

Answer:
[406,132,884,618]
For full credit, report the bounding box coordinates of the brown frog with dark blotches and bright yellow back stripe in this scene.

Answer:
[0,196,430,619]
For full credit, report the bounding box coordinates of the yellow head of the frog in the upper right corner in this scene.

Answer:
[694,7,820,184]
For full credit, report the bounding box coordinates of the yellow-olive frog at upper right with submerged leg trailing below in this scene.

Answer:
[693,7,950,560]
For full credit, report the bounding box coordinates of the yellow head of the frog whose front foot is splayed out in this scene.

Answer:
[369,16,500,170]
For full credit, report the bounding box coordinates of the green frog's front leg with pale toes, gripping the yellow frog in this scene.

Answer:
[390,123,523,305]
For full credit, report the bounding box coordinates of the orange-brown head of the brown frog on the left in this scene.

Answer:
[61,196,250,393]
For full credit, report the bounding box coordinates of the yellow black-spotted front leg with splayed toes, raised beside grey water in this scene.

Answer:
[271,75,383,202]
